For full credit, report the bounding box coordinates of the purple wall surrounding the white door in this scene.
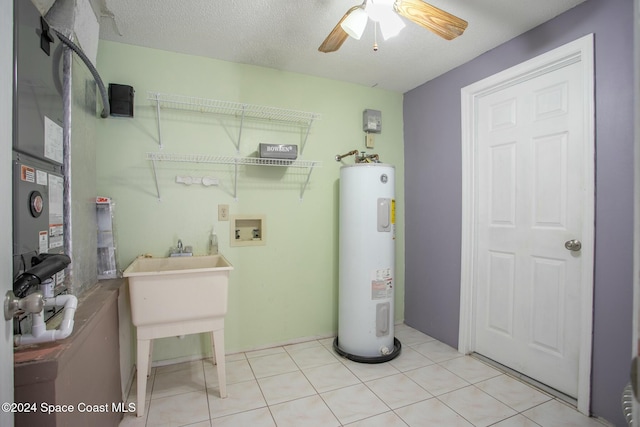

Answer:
[404,0,633,425]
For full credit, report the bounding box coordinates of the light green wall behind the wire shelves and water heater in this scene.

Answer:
[97,41,404,361]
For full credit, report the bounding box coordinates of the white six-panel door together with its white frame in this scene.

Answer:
[460,36,594,412]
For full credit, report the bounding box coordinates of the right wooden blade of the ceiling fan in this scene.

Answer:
[394,0,468,40]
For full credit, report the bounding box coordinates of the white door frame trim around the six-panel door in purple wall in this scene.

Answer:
[458,34,595,415]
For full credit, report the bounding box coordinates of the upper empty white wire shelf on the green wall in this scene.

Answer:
[147,92,320,126]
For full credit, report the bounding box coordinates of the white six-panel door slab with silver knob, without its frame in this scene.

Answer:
[475,63,584,397]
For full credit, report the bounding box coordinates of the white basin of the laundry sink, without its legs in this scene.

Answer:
[123,255,233,326]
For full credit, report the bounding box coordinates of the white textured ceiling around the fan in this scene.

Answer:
[100,0,584,92]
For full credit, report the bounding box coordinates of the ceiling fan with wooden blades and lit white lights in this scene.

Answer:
[318,0,468,53]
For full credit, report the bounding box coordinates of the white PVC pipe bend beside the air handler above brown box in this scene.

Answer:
[14,295,78,346]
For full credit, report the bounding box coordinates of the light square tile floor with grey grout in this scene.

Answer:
[120,325,604,427]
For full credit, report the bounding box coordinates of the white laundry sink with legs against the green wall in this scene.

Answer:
[123,255,233,417]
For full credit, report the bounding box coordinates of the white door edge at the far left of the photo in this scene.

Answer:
[0,1,13,426]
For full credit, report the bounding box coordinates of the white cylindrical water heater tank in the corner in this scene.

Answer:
[334,163,400,363]
